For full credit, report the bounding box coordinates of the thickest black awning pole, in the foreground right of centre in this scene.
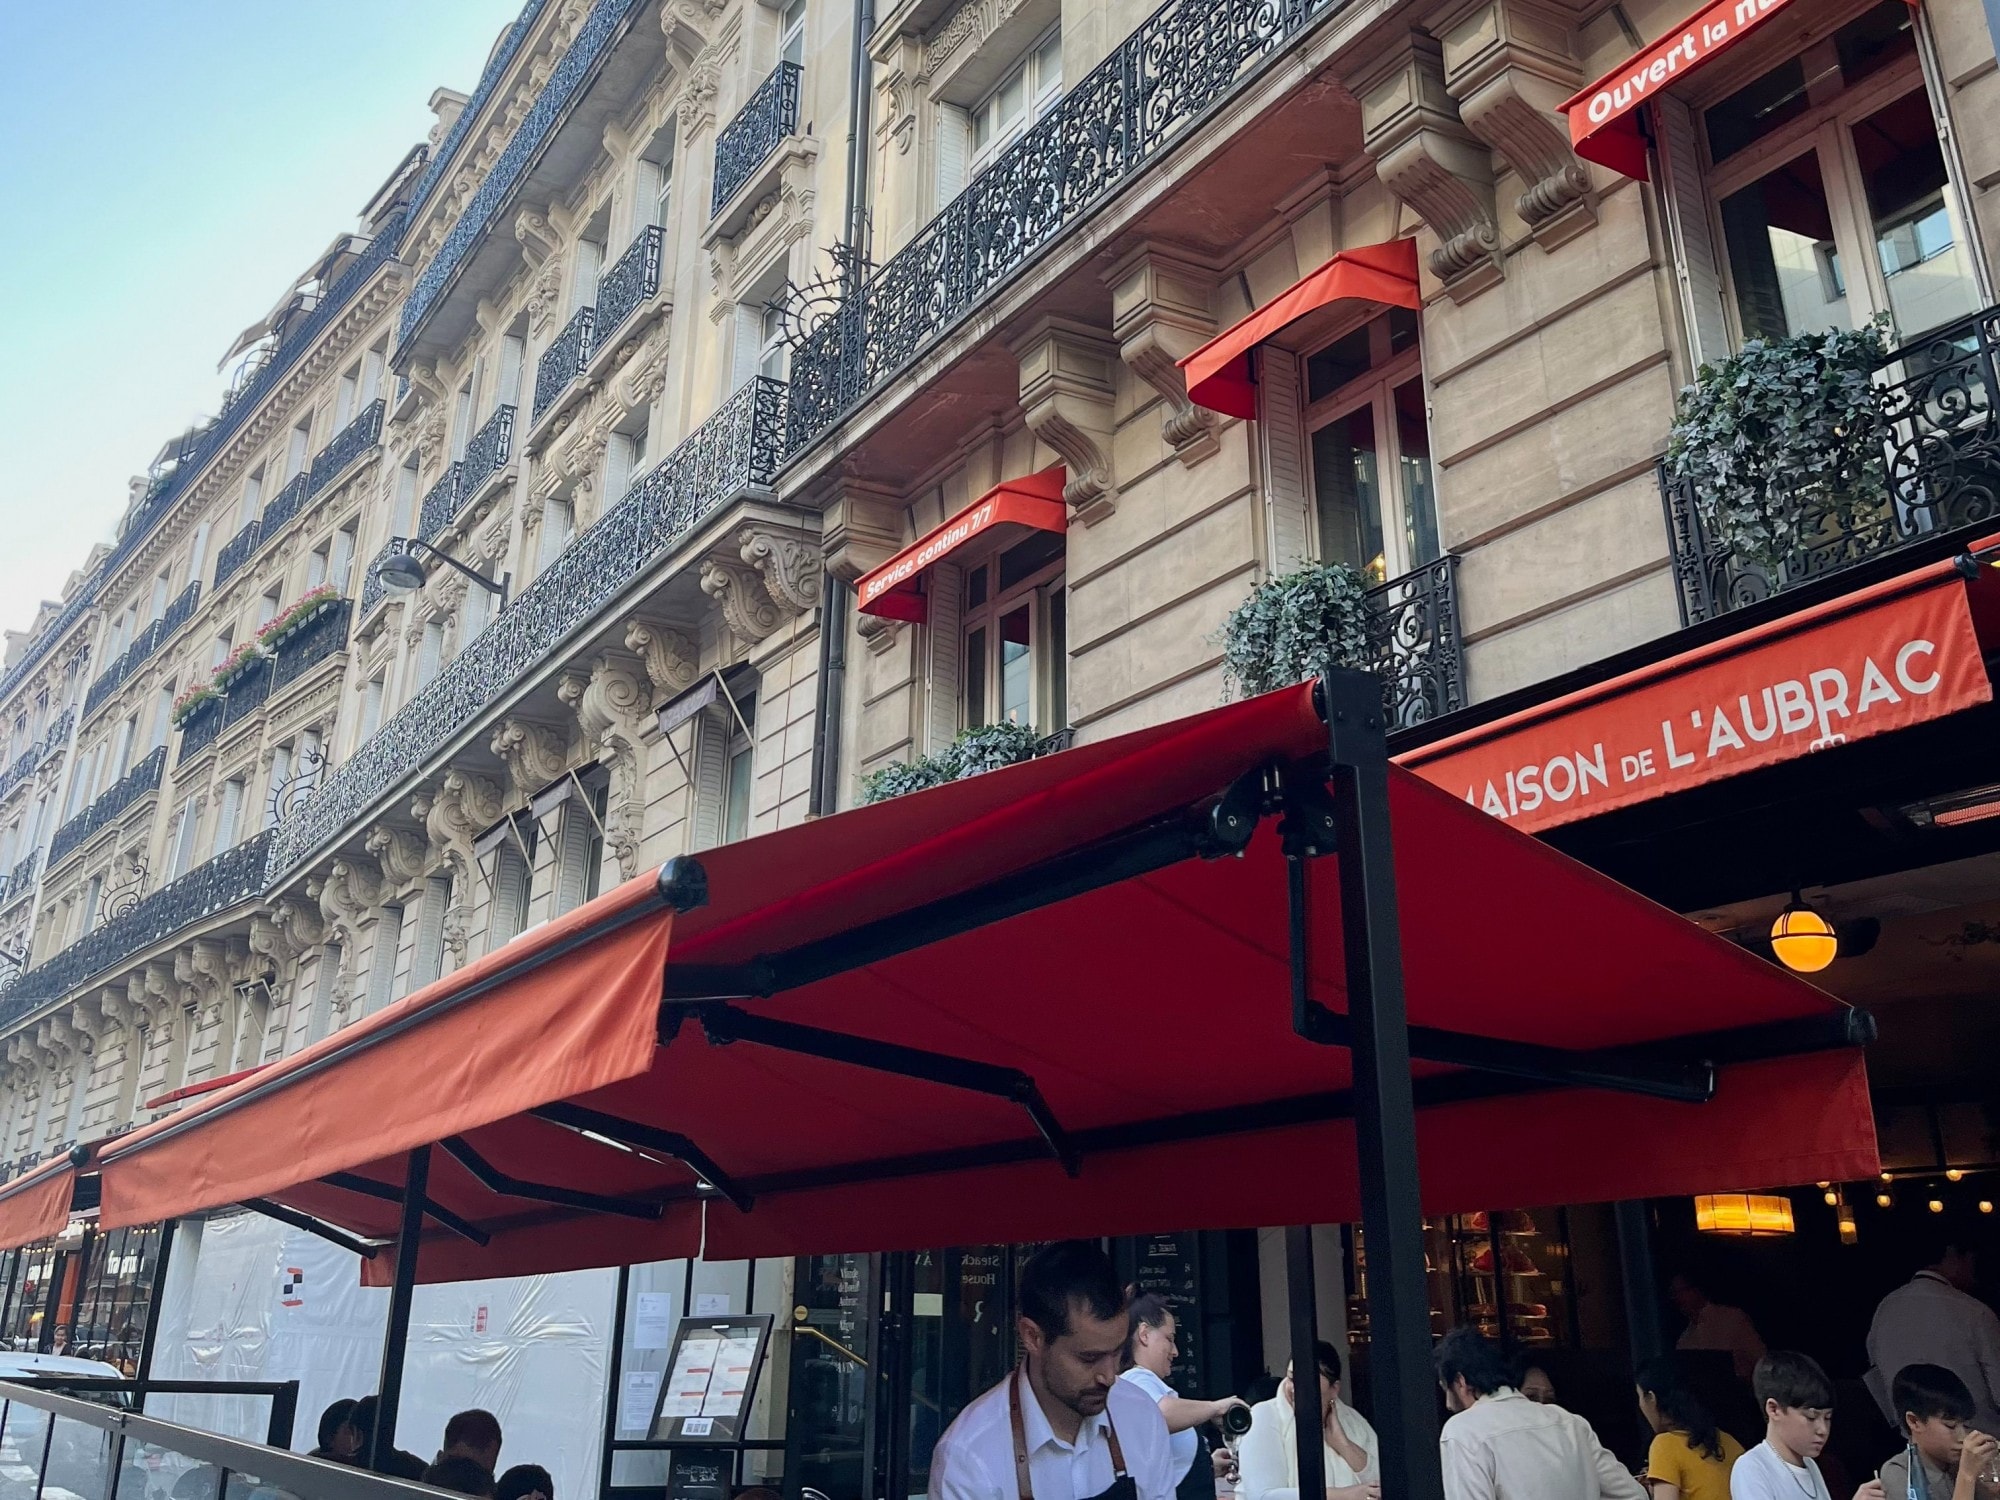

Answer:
[1320,670,1444,1500]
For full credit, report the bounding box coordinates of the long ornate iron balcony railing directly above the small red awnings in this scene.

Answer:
[788,0,1348,454]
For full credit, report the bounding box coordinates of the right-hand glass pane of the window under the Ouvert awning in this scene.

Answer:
[1854,88,1980,338]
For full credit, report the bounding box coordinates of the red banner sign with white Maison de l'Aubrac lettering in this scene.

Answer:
[1396,564,1994,832]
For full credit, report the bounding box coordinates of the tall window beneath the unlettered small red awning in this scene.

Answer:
[1304,308,1442,584]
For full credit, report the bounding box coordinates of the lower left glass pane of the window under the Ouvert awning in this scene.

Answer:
[1722,150,1852,338]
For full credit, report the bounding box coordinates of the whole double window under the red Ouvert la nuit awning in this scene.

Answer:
[1702,0,1980,342]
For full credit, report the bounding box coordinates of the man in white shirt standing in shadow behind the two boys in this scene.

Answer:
[1866,1234,2000,1436]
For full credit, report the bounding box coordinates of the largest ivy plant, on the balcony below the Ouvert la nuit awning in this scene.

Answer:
[1666,318,1890,568]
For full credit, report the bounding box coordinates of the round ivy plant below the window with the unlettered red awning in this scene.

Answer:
[1222,562,1374,698]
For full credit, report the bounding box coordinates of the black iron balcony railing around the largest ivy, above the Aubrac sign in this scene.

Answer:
[1660,308,2000,624]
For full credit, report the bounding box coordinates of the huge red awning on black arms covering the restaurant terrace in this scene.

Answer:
[90,684,1878,1280]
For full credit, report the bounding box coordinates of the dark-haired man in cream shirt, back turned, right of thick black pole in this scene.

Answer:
[1436,1328,1646,1500]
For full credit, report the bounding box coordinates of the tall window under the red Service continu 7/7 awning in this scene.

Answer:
[962,532,1070,732]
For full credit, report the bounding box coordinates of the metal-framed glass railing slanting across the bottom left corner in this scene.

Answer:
[0,1382,438,1500]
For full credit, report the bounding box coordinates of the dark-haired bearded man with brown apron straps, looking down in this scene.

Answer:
[930,1240,1174,1500]
